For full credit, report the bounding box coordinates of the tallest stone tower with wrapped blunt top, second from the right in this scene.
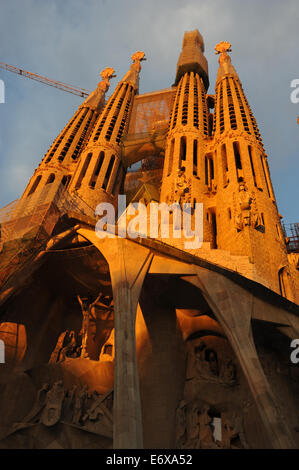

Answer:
[160,30,217,246]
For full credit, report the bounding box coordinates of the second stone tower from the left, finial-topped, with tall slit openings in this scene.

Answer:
[70,51,145,209]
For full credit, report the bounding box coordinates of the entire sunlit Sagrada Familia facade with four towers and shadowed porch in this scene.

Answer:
[0,30,299,449]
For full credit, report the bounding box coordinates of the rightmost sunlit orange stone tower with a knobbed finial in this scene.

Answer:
[213,42,293,299]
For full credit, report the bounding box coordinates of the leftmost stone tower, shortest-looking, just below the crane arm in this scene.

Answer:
[16,67,115,214]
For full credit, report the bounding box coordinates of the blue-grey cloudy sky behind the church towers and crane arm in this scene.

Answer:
[0,0,299,222]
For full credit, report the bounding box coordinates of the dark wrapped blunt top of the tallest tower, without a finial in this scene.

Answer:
[175,29,209,90]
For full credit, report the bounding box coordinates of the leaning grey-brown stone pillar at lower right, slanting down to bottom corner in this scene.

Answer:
[190,266,295,449]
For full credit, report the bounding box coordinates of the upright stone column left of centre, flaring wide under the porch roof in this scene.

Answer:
[78,229,153,449]
